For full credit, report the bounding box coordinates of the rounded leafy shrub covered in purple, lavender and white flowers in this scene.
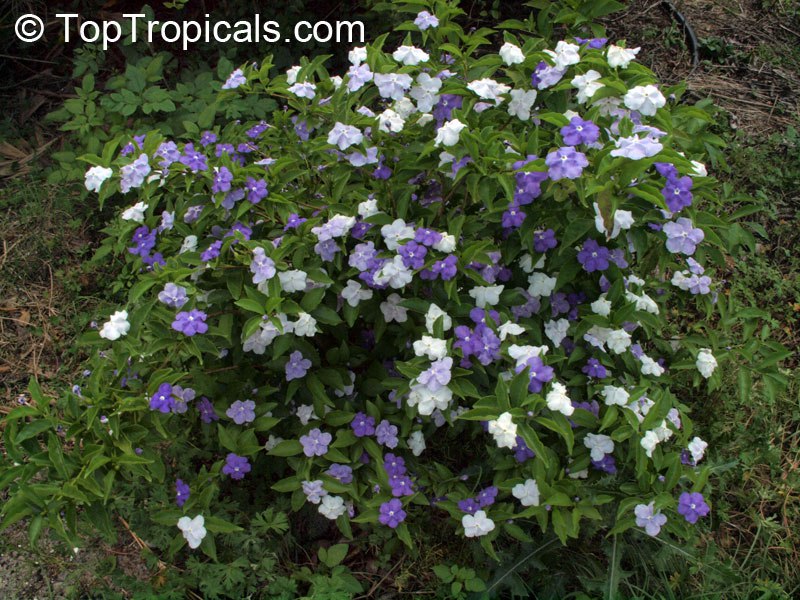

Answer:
[6,1,780,580]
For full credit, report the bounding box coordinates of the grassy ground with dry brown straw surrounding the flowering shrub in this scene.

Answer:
[0,0,800,599]
